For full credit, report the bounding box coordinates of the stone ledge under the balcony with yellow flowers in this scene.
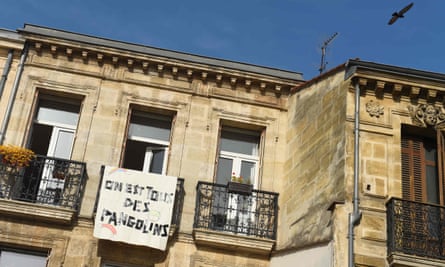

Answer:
[0,199,75,225]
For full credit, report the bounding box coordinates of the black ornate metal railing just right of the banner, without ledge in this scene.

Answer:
[194,182,278,240]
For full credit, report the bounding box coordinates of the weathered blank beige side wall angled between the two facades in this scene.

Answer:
[277,69,348,258]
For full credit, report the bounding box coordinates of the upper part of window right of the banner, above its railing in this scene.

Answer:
[216,127,260,186]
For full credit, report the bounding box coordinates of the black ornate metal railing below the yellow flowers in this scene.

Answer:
[0,155,86,211]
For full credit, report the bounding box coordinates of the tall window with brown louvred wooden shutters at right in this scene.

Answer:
[401,126,445,205]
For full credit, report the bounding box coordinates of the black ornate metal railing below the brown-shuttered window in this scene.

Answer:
[386,198,445,259]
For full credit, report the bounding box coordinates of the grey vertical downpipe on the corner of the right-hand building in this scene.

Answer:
[348,82,362,267]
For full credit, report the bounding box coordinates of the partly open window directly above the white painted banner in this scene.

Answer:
[123,110,172,174]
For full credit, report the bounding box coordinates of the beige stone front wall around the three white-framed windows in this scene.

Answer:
[0,34,298,267]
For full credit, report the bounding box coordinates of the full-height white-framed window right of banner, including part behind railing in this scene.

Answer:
[211,126,261,234]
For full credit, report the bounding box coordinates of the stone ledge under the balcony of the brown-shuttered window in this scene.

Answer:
[388,253,445,267]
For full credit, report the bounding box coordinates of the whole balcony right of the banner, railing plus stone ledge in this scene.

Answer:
[194,182,278,254]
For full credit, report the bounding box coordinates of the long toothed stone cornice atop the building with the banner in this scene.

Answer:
[22,35,301,95]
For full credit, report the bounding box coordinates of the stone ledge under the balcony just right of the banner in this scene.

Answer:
[193,229,275,255]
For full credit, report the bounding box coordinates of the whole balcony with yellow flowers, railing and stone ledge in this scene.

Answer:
[0,155,86,224]
